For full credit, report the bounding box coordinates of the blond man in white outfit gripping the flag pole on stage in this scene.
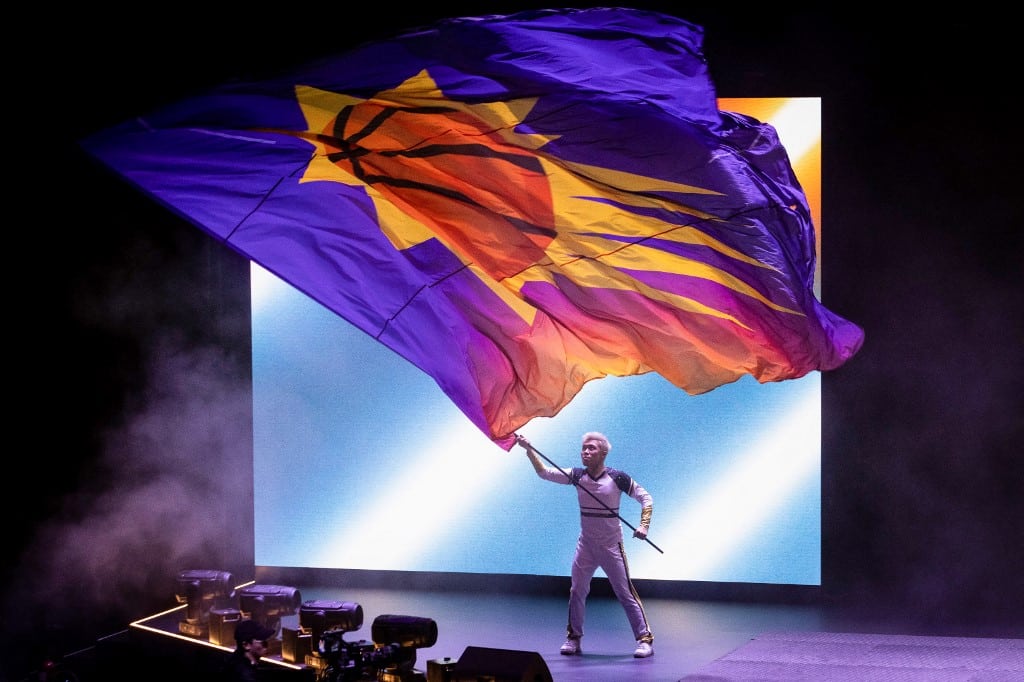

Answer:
[515,431,664,658]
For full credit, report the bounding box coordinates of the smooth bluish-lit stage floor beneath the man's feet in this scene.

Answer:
[112,585,1013,682]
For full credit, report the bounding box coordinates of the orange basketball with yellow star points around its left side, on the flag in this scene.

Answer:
[288,73,555,281]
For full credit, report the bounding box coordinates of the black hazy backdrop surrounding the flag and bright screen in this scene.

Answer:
[6,2,1024,680]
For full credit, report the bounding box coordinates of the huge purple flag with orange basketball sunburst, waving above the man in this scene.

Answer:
[83,8,863,449]
